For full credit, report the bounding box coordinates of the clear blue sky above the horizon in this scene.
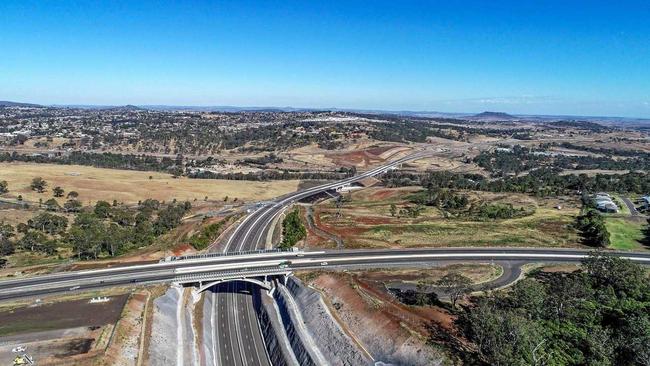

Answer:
[0,0,650,117]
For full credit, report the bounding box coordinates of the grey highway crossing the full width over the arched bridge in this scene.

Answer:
[0,248,650,300]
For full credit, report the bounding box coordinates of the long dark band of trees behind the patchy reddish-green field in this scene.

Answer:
[381,168,650,197]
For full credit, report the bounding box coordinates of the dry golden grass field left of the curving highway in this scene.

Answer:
[0,163,299,204]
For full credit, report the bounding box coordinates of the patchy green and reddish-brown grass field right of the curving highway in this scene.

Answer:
[316,188,580,248]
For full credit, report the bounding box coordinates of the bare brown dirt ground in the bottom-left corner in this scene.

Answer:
[0,294,132,365]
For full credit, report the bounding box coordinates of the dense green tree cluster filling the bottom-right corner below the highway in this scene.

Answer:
[454,255,650,365]
